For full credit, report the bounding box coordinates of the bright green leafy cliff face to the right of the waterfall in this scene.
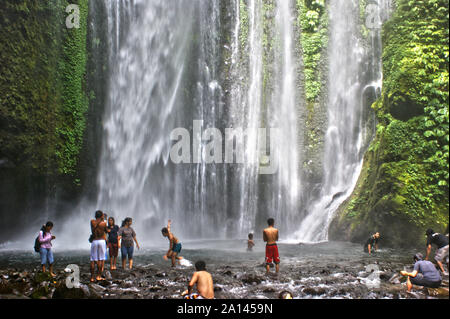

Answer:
[332,0,449,245]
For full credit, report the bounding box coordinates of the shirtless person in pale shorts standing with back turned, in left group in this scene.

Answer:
[91,210,106,282]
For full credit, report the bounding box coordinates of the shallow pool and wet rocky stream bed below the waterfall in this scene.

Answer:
[0,240,449,299]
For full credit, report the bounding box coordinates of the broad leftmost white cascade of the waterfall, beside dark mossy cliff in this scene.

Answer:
[97,0,192,238]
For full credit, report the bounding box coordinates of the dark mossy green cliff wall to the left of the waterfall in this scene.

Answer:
[0,0,88,181]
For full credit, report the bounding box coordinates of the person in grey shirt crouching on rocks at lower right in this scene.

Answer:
[400,253,442,292]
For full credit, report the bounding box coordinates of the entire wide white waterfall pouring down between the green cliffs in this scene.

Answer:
[58,0,388,248]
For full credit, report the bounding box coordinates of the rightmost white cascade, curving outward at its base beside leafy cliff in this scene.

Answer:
[295,0,389,242]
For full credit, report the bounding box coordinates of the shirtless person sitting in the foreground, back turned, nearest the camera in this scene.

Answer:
[182,260,214,299]
